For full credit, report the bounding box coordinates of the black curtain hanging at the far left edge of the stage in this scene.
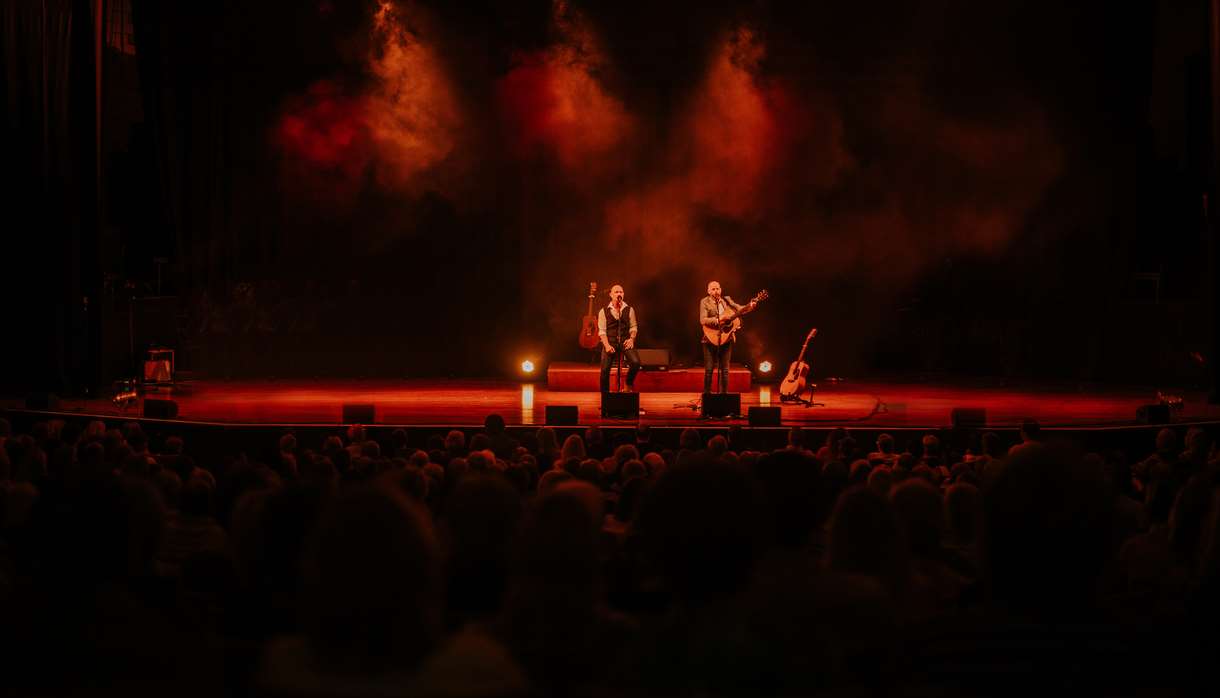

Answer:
[0,0,100,394]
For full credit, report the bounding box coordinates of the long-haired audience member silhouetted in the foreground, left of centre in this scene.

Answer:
[259,486,526,696]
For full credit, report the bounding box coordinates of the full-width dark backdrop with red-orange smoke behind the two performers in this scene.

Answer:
[0,0,1210,390]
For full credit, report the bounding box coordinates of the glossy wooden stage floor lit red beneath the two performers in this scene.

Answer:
[9,380,1220,428]
